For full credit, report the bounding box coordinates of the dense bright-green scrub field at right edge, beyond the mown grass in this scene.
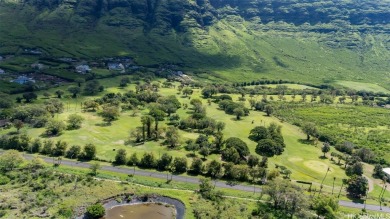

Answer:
[276,104,390,161]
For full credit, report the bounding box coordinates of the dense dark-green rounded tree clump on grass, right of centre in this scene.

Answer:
[249,123,286,157]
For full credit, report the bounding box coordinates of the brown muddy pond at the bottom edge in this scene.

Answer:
[105,203,176,219]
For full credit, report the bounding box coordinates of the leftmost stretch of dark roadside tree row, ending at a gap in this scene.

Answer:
[0,134,96,160]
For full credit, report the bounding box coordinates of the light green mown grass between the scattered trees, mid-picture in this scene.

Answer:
[2,79,358,191]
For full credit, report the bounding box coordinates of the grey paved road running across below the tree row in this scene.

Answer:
[6,151,390,214]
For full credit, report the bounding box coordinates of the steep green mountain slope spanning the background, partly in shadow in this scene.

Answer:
[0,0,390,89]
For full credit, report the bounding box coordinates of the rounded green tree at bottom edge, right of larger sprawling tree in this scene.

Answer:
[312,195,339,219]
